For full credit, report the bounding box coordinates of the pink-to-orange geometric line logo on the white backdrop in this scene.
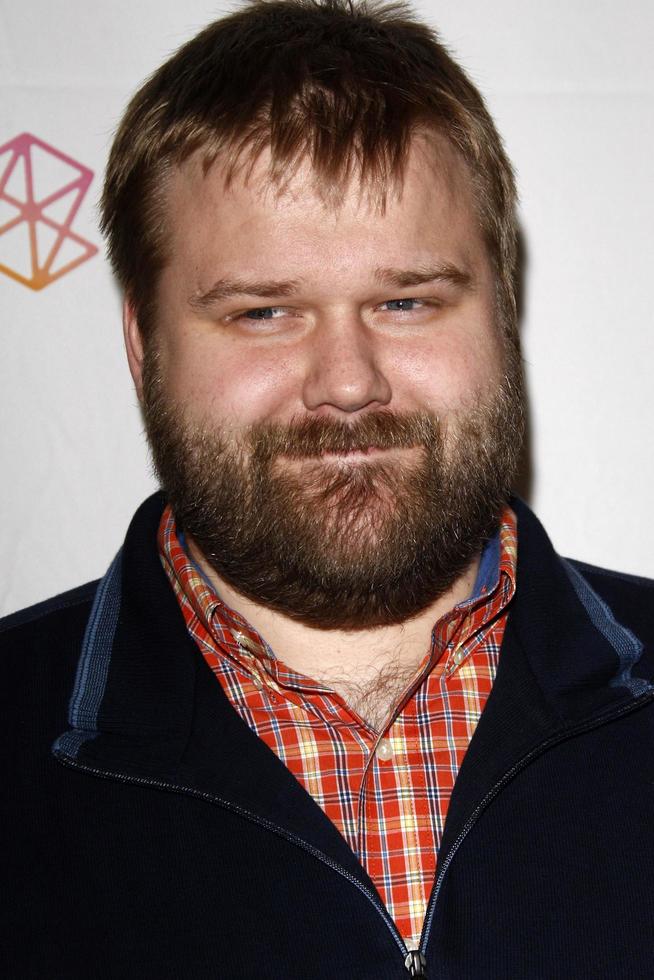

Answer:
[0,133,98,289]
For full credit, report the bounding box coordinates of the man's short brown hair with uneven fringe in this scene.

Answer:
[102,0,516,339]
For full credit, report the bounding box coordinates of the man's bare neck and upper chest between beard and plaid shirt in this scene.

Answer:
[187,538,479,730]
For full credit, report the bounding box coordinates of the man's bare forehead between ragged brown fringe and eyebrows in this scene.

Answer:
[166,134,485,285]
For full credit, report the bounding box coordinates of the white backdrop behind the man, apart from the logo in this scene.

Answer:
[0,0,654,612]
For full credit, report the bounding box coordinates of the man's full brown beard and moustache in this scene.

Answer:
[143,350,524,630]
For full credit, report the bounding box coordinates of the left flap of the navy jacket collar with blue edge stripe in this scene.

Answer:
[53,494,373,876]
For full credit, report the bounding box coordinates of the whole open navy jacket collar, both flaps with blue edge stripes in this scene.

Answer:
[54,494,649,877]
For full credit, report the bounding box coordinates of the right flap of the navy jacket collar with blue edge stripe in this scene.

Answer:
[441,500,654,853]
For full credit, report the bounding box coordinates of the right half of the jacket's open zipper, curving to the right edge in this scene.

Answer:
[420,689,654,964]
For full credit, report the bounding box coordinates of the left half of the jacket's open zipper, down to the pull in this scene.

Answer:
[53,750,416,964]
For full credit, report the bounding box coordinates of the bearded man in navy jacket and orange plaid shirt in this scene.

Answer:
[2,0,654,980]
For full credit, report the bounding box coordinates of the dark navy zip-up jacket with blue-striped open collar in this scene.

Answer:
[0,496,654,980]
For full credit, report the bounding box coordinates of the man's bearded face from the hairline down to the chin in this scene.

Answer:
[131,141,522,628]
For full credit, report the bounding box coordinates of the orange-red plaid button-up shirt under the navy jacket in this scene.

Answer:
[159,508,517,948]
